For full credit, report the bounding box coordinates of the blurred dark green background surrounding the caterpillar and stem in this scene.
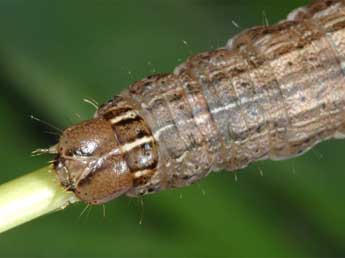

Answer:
[0,0,345,257]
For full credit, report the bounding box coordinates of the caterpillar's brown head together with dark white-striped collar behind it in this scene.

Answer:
[54,97,157,204]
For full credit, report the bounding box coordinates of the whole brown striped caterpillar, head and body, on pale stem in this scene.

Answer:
[54,0,345,204]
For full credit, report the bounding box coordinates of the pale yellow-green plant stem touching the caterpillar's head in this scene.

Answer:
[0,166,78,233]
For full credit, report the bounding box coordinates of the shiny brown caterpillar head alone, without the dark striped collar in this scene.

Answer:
[54,118,133,204]
